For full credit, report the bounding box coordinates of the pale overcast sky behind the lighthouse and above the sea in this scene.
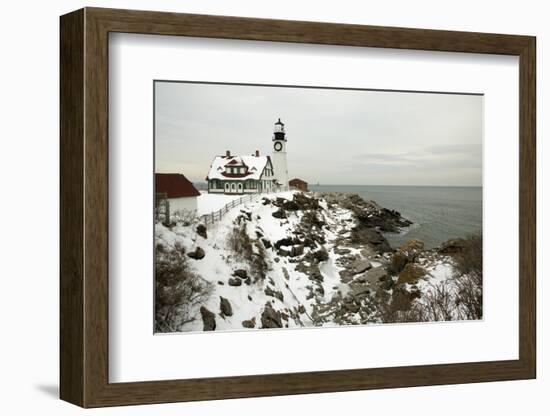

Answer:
[155,82,483,186]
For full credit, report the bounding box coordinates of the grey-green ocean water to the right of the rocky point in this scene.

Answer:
[309,185,483,248]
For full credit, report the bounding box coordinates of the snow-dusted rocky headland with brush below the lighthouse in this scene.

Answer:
[155,191,482,332]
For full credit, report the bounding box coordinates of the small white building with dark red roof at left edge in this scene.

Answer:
[155,173,200,213]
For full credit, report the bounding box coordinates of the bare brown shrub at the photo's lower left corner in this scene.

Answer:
[155,243,216,332]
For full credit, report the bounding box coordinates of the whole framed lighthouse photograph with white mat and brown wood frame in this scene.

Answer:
[60,8,536,407]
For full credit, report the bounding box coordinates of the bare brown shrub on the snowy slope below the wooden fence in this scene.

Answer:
[227,223,269,282]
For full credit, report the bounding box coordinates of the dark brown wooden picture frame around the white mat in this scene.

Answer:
[60,8,536,407]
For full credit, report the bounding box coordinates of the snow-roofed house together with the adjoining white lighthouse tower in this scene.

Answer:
[206,119,288,194]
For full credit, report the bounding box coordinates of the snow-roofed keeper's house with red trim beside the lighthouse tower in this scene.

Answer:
[206,150,277,194]
